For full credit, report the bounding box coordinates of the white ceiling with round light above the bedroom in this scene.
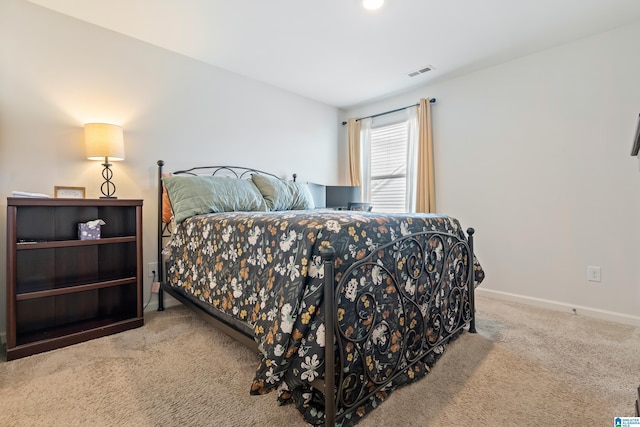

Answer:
[29,0,640,108]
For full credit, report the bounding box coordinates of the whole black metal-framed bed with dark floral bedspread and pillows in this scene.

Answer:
[158,160,484,426]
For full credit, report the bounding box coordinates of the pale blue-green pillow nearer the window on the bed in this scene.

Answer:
[251,174,314,211]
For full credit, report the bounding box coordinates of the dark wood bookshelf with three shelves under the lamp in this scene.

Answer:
[6,197,144,360]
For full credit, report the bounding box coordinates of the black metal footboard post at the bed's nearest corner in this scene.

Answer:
[320,246,336,427]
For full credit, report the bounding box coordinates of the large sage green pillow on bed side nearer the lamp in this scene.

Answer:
[162,176,267,222]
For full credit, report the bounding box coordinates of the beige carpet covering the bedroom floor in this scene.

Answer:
[0,297,640,427]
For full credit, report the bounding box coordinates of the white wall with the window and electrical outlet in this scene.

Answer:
[343,22,640,324]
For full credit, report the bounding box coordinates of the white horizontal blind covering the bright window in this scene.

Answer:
[371,121,408,212]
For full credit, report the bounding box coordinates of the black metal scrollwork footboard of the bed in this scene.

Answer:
[325,229,475,421]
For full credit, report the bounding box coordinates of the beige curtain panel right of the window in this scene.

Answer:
[416,98,436,212]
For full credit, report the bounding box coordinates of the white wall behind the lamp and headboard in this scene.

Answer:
[0,0,339,331]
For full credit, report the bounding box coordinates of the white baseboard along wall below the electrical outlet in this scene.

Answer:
[476,288,640,326]
